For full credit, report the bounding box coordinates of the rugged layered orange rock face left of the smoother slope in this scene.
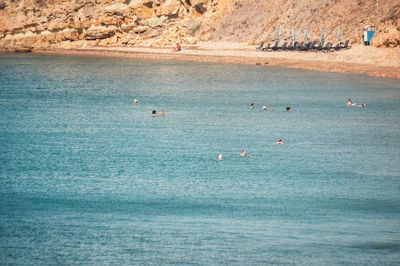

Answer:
[0,0,212,48]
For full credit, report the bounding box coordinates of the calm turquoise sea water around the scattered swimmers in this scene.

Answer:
[0,54,400,265]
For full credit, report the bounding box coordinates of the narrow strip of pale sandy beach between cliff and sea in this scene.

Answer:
[3,42,400,78]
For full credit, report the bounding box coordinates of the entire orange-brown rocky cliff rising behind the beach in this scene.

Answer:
[0,0,400,49]
